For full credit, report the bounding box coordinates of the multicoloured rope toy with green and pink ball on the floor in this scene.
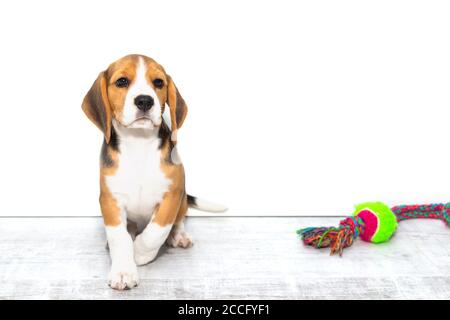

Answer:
[297,202,450,256]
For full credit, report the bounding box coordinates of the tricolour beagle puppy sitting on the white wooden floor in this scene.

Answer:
[82,55,226,290]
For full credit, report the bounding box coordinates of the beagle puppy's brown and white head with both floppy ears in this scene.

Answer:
[82,55,187,143]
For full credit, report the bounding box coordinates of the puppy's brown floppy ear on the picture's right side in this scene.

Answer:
[167,75,187,142]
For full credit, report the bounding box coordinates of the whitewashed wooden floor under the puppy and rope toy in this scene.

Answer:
[0,217,450,299]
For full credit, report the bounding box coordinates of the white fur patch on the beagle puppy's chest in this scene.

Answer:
[106,122,171,225]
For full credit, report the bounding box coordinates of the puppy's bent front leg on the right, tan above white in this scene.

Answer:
[134,191,183,266]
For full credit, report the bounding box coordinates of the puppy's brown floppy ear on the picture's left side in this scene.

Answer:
[81,71,111,143]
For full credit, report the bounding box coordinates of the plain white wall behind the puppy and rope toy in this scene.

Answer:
[0,0,450,215]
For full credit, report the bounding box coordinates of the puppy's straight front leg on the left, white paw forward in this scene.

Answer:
[100,194,138,290]
